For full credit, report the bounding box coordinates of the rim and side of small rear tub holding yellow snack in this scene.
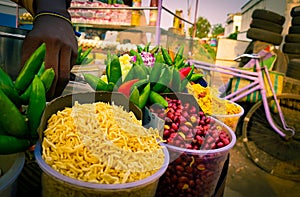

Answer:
[213,100,244,132]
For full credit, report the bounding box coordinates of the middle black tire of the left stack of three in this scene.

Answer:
[250,18,283,34]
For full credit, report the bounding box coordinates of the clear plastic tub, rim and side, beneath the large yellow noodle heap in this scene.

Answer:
[34,142,169,197]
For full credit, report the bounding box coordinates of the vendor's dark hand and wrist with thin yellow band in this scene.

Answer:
[22,0,78,100]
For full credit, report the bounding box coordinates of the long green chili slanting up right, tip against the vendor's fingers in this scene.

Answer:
[15,43,46,92]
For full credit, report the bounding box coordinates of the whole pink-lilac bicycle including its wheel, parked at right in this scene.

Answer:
[190,54,300,180]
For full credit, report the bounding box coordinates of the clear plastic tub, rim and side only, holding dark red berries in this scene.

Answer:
[156,118,236,197]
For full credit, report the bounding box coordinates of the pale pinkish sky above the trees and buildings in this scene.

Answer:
[142,0,249,29]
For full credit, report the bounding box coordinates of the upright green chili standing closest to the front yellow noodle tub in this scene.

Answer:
[27,75,46,139]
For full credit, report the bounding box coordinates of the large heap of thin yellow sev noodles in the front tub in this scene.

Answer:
[42,102,164,184]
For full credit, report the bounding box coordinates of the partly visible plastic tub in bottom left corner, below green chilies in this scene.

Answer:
[0,152,25,197]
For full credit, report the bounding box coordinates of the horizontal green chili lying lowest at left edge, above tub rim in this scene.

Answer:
[0,135,31,155]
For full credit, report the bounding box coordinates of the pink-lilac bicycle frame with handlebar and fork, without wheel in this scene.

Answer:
[189,54,295,138]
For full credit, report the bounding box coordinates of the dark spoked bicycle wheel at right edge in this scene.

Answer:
[242,94,300,181]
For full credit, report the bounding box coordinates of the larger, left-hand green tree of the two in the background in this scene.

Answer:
[189,16,211,38]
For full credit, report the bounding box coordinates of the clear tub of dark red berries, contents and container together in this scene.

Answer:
[149,93,236,196]
